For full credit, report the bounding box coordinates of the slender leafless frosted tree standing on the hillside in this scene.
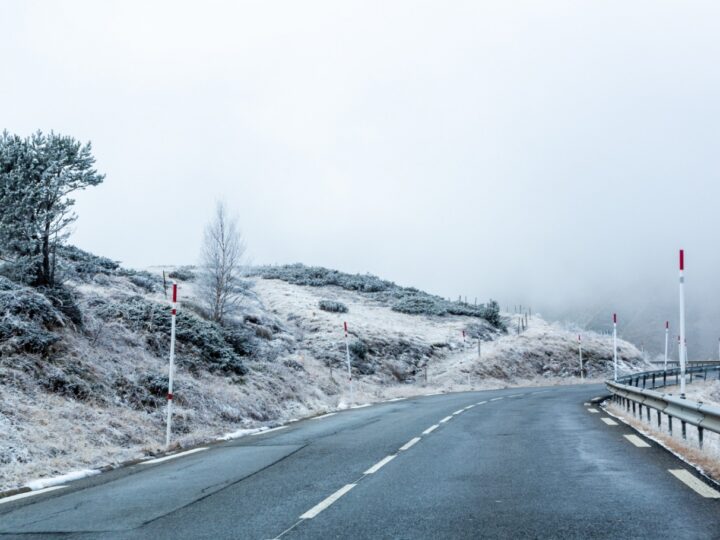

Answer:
[199,202,246,323]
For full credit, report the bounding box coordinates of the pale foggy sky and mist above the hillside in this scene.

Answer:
[0,0,720,359]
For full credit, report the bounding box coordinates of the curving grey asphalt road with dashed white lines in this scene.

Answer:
[0,386,720,540]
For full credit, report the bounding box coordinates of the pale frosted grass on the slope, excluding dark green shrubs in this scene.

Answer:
[0,276,640,490]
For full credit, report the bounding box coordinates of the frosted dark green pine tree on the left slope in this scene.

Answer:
[0,131,105,287]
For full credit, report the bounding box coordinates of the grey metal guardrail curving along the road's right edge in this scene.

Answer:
[605,365,720,448]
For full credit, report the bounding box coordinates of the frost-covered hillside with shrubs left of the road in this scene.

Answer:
[0,250,641,490]
